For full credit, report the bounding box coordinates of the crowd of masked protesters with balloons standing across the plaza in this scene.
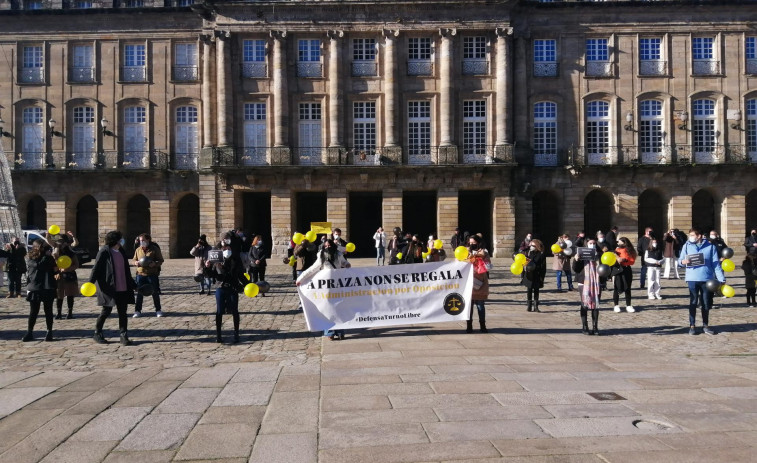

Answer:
[0,223,757,345]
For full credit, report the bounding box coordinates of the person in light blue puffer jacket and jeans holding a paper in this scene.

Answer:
[680,228,725,335]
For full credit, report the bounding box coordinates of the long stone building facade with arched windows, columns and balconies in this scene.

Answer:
[0,0,757,257]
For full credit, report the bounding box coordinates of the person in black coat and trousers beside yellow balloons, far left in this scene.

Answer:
[22,240,58,342]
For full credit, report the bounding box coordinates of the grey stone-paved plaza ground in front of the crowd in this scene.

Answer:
[0,259,757,463]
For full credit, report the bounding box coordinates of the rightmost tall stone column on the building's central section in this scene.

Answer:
[494,27,513,159]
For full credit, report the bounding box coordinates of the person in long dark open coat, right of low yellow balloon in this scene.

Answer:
[89,231,137,346]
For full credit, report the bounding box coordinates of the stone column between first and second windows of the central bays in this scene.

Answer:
[270,31,291,164]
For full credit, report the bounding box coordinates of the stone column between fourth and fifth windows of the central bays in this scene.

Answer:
[437,29,457,164]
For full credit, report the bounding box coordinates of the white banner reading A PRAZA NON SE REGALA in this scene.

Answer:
[298,260,473,331]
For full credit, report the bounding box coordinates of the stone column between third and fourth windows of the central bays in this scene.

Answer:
[383,29,402,163]
